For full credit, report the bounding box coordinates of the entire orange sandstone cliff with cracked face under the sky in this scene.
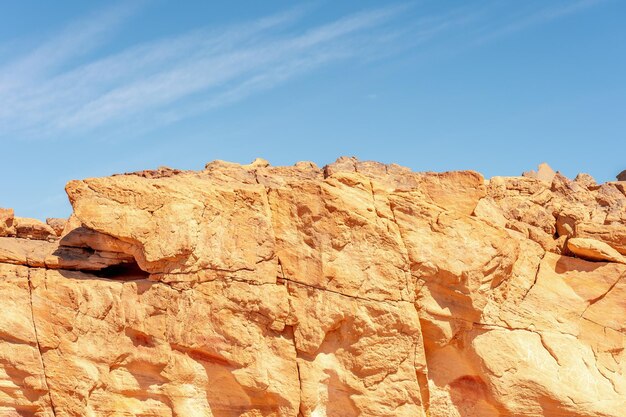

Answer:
[0,158,626,417]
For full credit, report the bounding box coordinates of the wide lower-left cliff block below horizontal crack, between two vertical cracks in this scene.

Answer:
[30,269,300,417]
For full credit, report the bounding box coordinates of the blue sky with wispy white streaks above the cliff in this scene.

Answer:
[0,0,626,218]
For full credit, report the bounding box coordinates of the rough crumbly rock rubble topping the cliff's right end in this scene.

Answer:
[474,164,626,254]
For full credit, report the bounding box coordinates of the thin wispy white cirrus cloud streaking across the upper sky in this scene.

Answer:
[0,0,601,138]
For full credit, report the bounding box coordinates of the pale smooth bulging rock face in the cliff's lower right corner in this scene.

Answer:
[478,253,626,416]
